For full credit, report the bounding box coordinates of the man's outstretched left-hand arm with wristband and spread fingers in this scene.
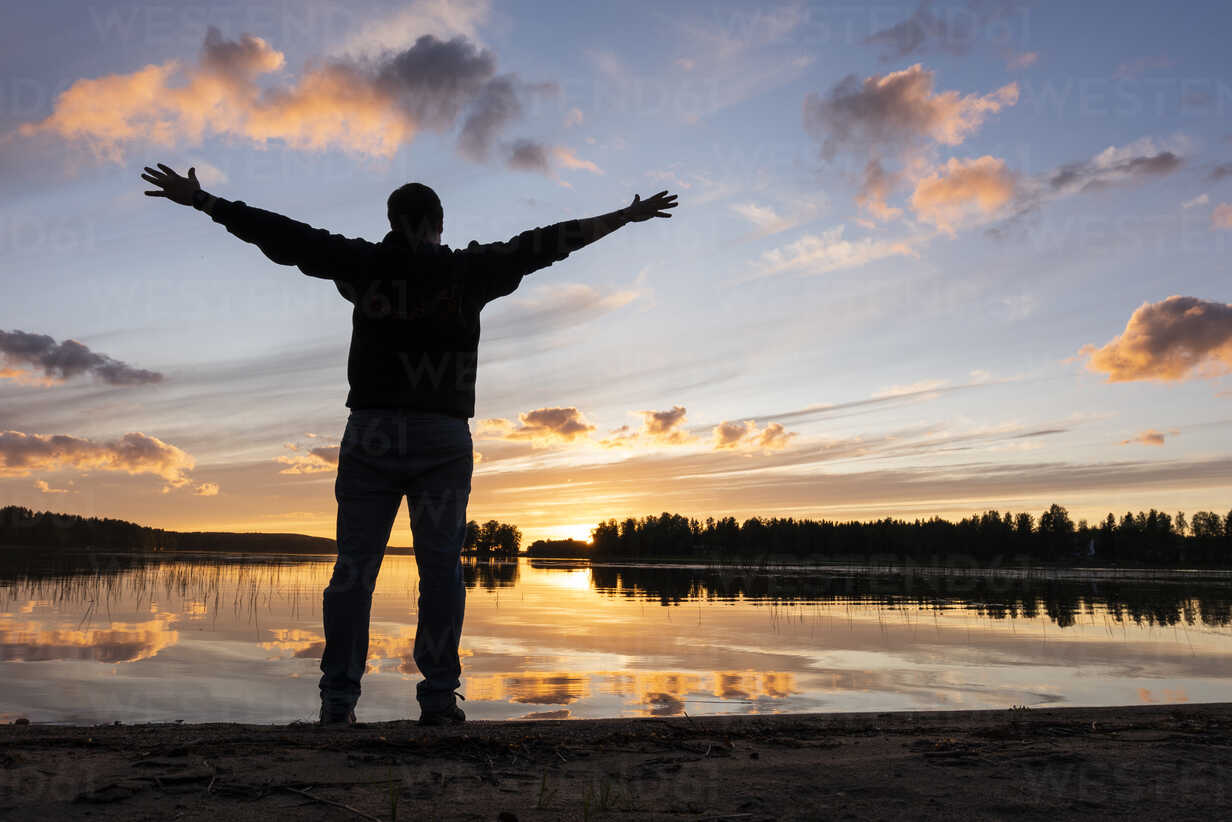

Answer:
[142,163,430,280]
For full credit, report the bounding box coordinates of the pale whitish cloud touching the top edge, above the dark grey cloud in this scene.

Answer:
[331,0,492,57]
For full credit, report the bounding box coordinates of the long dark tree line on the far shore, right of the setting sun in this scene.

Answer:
[590,504,1232,567]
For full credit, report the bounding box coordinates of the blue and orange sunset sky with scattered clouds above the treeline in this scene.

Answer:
[0,0,1232,545]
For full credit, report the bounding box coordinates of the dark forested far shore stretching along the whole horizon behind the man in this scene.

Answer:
[9,505,1232,568]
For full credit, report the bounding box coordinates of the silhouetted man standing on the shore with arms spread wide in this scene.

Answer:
[142,164,676,725]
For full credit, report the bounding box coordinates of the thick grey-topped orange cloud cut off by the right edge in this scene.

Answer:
[1079,296,1232,382]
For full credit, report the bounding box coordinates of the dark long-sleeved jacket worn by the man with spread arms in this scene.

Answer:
[213,200,586,418]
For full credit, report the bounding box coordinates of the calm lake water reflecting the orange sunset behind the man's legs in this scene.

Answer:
[0,551,1232,723]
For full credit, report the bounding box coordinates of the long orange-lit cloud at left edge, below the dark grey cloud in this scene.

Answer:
[0,431,195,488]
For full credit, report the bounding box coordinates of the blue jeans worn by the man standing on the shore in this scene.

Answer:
[320,409,474,712]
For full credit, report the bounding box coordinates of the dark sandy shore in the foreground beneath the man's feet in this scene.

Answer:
[0,704,1232,822]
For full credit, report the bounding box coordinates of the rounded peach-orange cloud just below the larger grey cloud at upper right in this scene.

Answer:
[910,155,1018,234]
